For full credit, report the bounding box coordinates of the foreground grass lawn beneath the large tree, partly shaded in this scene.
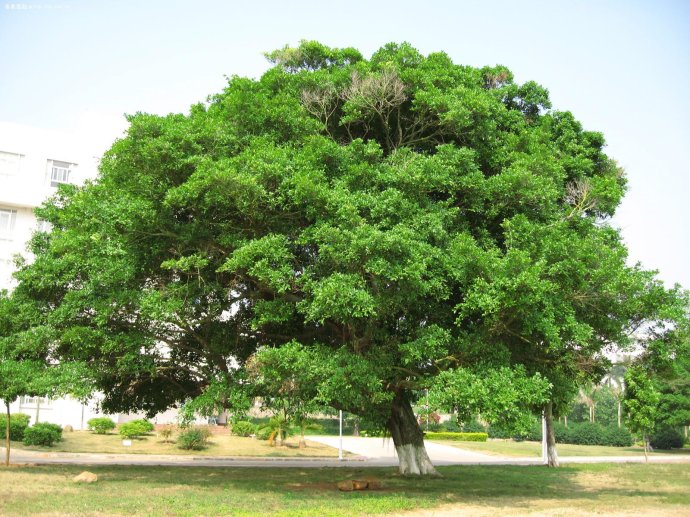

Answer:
[0,464,690,516]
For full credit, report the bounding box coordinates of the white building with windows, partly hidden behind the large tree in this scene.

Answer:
[0,123,115,429]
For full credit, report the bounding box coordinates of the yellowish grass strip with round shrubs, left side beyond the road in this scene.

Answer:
[12,431,350,458]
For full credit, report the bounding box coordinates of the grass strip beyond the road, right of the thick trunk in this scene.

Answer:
[434,440,690,457]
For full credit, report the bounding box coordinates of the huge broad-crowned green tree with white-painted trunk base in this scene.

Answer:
[13,42,684,474]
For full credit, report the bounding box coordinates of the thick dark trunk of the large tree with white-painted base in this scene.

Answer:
[388,393,439,476]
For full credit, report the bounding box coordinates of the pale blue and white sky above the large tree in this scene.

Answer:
[0,0,690,288]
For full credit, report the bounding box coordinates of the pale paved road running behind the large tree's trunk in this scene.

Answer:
[0,436,690,468]
